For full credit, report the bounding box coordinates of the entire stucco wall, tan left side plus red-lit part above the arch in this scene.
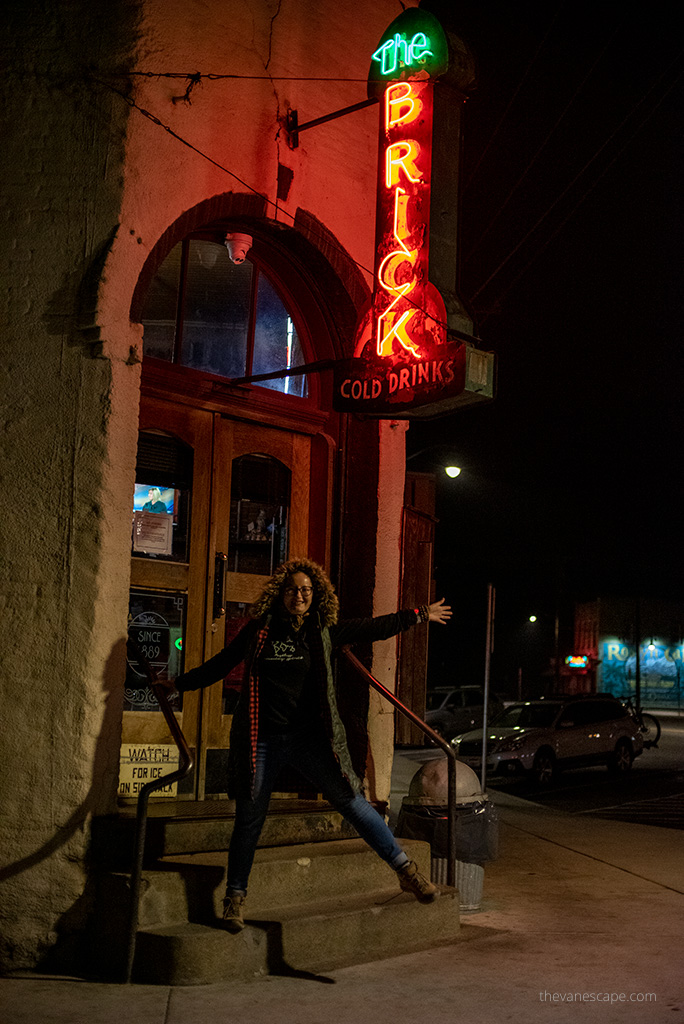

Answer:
[0,0,417,969]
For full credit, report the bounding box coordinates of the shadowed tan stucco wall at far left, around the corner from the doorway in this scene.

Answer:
[0,3,138,968]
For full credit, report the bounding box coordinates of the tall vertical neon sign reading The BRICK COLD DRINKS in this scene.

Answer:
[335,9,473,418]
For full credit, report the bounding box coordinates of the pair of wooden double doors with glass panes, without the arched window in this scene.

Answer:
[119,398,310,801]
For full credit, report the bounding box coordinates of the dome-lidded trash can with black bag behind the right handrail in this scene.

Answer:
[395,758,499,910]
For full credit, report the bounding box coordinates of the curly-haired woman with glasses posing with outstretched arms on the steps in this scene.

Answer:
[169,558,452,932]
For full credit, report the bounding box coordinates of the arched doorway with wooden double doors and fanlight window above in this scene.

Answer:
[119,216,362,802]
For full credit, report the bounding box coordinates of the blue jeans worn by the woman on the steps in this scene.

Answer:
[226,730,409,893]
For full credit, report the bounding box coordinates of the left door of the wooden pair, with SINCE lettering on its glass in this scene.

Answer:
[119,398,212,802]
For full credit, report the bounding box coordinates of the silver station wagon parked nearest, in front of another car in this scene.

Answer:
[452,694,643,784]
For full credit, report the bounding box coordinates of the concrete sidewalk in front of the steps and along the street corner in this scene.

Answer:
[0,778,684,1024]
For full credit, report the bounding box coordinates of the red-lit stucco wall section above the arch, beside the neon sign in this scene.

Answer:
[108,0,415,323]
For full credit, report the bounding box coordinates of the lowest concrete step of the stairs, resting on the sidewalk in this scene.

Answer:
[133,887,460,985]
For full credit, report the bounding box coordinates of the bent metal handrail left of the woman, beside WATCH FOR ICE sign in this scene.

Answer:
[124,638,195,984]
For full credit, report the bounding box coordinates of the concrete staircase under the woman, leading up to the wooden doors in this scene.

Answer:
[93,823,459,985]
